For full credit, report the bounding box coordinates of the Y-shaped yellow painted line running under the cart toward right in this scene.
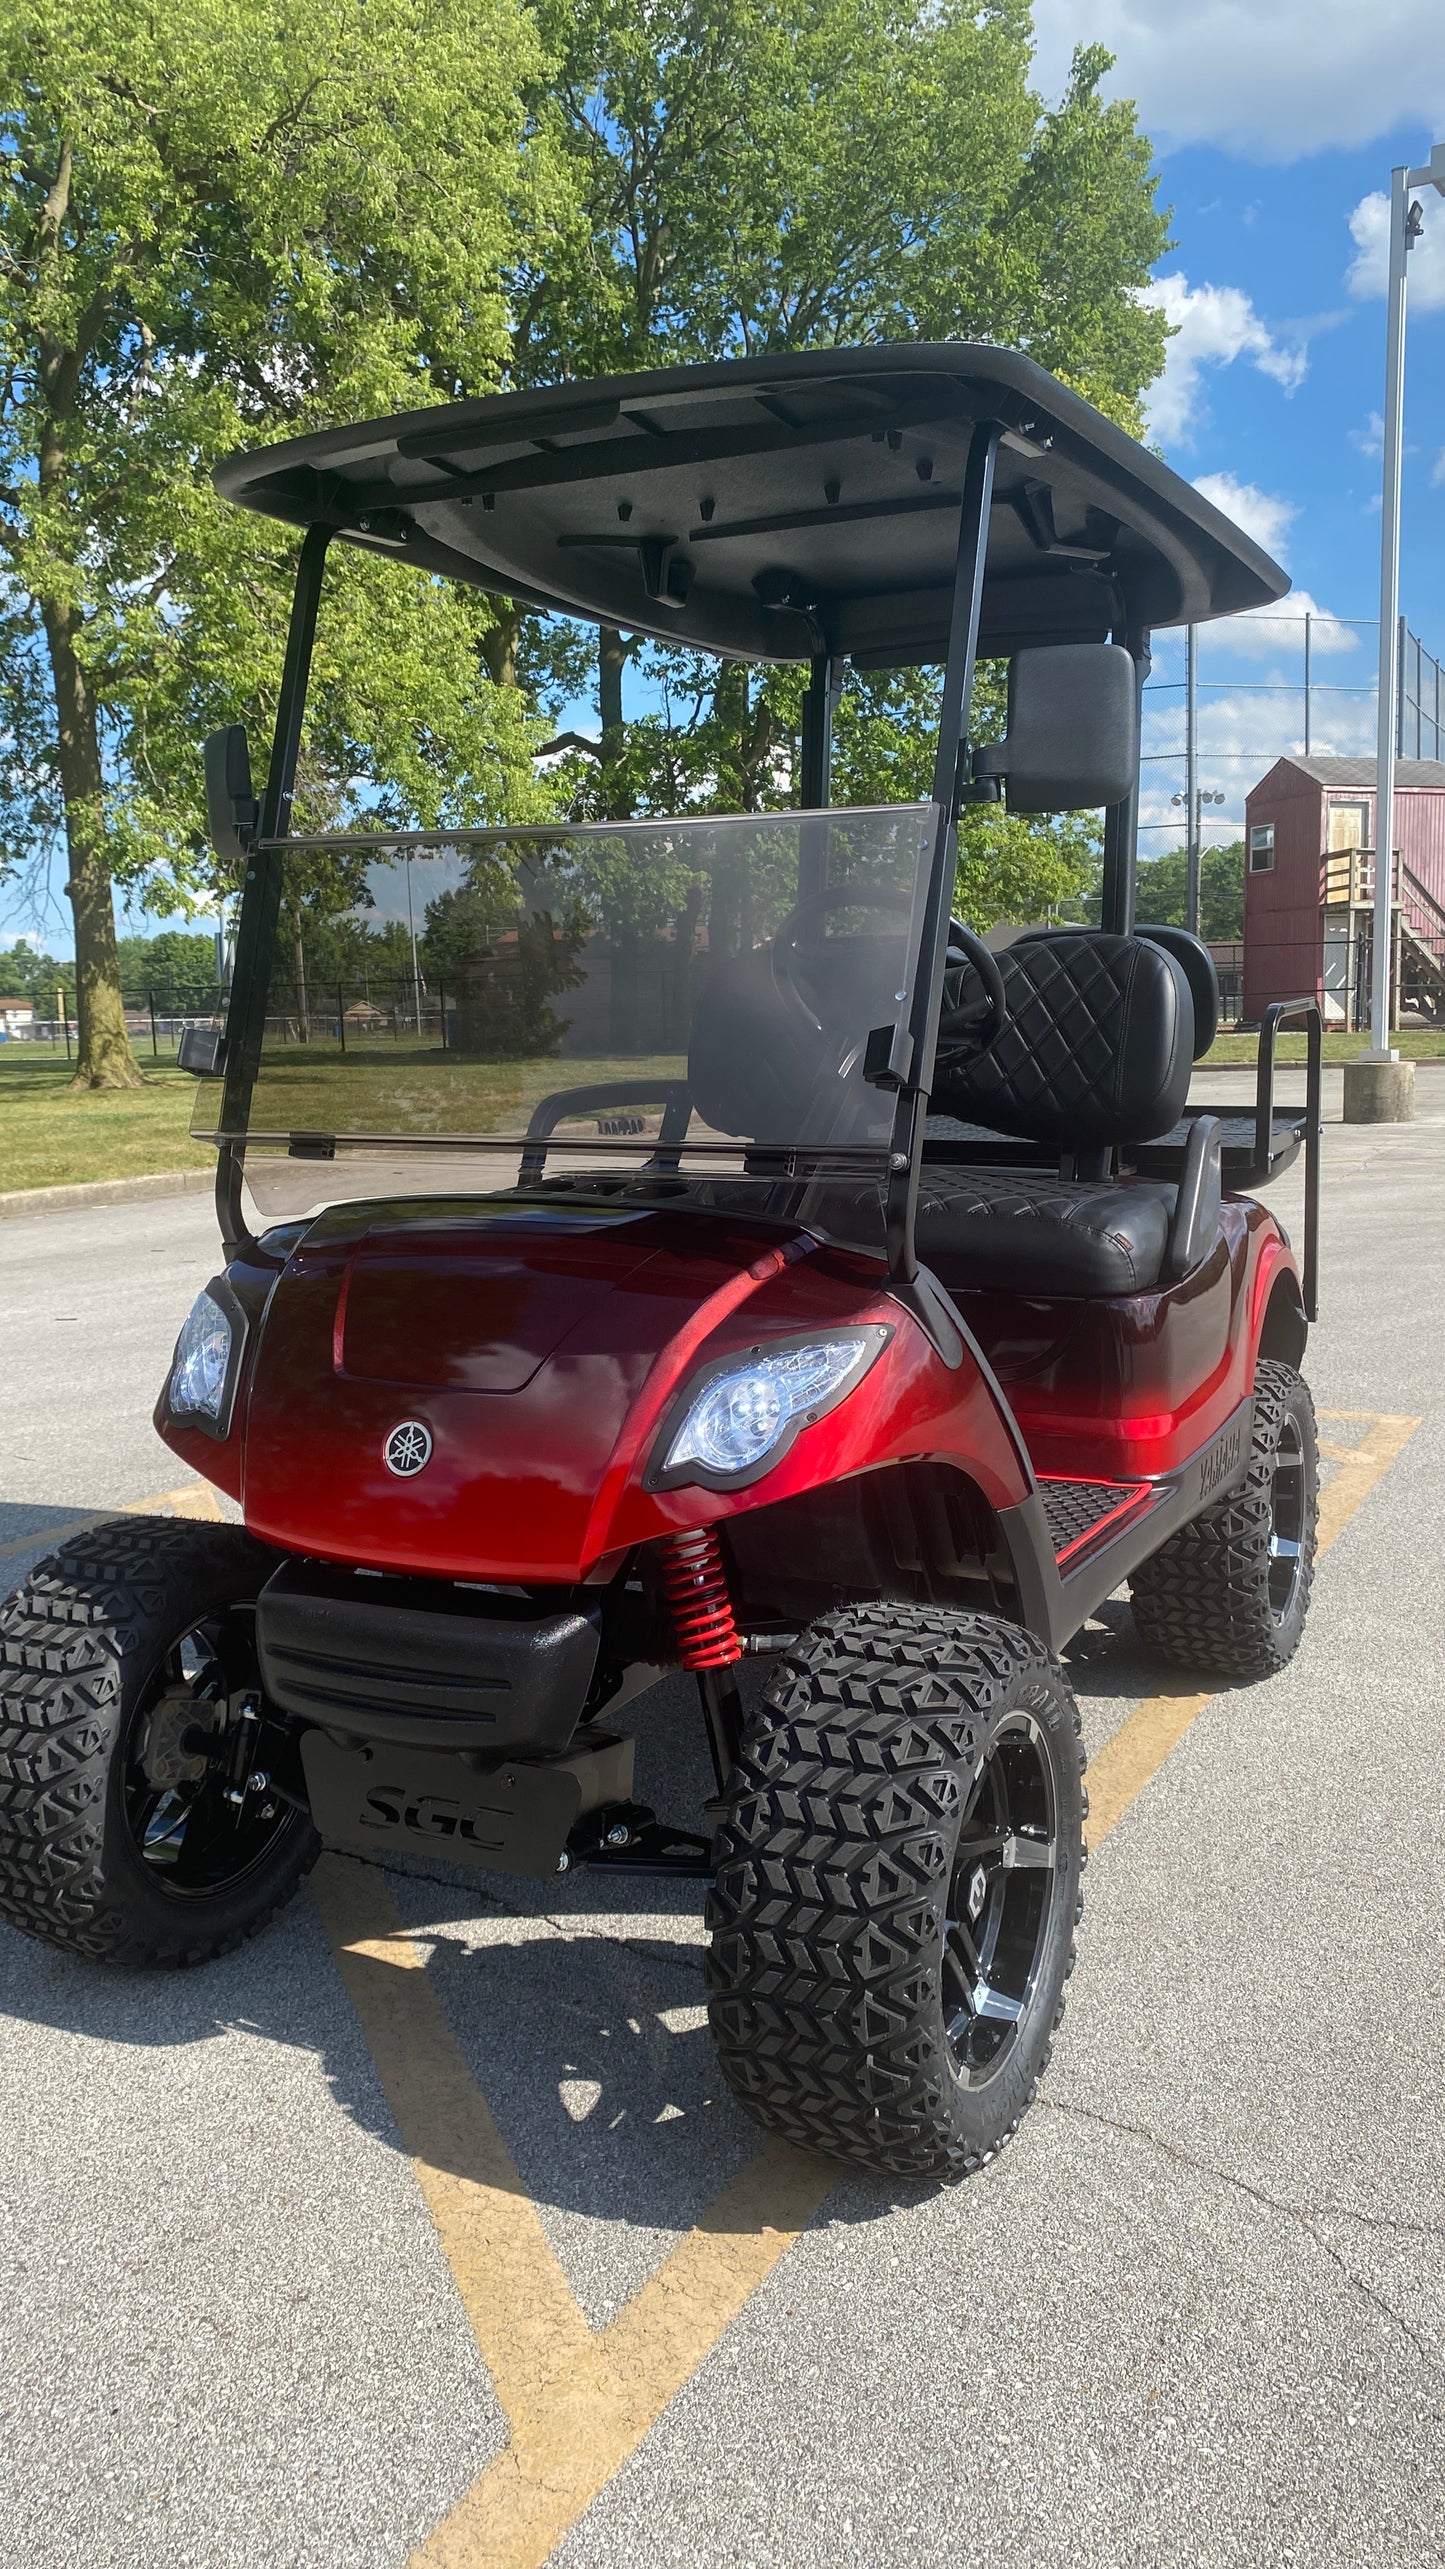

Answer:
[314,1410,1419,2569]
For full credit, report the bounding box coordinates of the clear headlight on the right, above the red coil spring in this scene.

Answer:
[653,1328,892,1487]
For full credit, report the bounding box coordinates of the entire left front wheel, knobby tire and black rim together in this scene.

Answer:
[0,1516,319,1968]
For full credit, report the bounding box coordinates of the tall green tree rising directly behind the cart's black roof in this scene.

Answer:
[512,0,1167,873]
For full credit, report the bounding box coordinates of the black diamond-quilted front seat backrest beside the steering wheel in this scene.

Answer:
[933,927,1193,1151]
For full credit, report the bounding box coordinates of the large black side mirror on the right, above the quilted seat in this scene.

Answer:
[974,642,1139,812]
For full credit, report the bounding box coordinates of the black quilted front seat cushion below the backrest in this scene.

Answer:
[918,1169,1175,1295]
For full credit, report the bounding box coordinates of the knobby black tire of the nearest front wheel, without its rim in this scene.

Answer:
[707,1603,1088,2184]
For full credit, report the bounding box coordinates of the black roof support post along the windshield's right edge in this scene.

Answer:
[884,419,1003,1325]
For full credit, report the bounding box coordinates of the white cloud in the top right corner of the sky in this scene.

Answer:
[1034,0,1445,162]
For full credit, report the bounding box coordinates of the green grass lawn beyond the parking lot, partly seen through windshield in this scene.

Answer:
[0,1028,1445,1192]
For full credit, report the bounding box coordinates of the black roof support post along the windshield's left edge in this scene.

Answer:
[216,527,334,1256]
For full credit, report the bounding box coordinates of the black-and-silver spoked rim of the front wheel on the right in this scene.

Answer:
[944,1714,1059,2086]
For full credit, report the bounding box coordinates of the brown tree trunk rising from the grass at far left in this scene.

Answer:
[41,599,144,1089]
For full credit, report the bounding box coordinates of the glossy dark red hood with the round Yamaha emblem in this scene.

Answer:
[234,1202,905,1583]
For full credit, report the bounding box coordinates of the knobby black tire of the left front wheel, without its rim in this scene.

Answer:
[0,1516,319,1968]
